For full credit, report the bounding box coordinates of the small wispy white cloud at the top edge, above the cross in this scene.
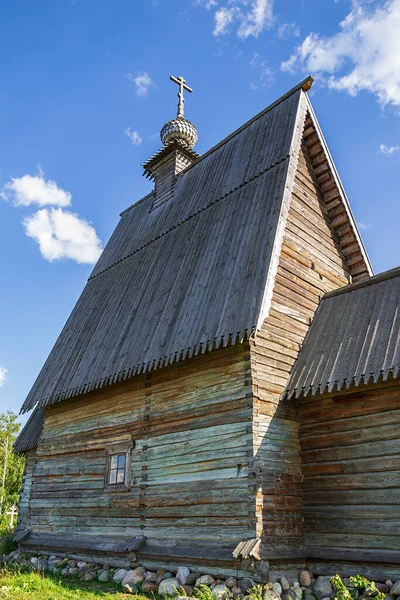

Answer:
[214,0,273,40]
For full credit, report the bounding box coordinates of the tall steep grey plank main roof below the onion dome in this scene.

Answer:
[22,80,370,411]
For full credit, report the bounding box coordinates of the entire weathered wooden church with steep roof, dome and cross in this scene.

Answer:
[15,78,400,579]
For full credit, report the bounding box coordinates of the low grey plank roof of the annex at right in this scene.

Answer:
[286,267,400,397]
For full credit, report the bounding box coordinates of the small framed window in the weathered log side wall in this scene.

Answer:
[104,441,133,491]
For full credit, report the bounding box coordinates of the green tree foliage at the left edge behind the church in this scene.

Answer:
[0,411,25,514]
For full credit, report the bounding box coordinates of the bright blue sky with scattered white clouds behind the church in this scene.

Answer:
[0,0,400,422]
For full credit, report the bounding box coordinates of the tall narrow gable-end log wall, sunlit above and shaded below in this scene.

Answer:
[251,142,349,560]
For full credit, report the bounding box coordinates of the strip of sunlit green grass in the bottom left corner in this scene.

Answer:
[0,568,153,600]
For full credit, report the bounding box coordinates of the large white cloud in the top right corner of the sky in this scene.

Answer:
[281,0,400,107]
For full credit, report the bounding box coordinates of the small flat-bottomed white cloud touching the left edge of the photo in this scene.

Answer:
[0,170,72,206]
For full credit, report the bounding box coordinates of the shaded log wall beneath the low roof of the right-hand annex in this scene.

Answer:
[298,384,400,581]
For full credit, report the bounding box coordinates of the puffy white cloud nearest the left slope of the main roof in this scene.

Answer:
[22,208,102,264]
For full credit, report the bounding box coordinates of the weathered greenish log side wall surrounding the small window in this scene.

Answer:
[25,345,254,572]
